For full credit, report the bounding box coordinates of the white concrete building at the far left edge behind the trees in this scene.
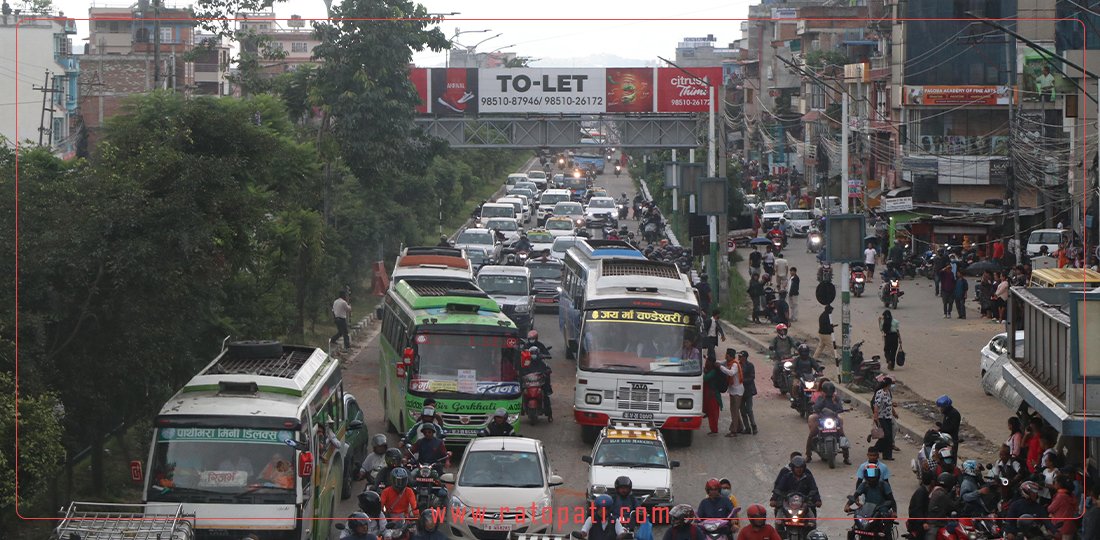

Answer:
[0,11,80,157]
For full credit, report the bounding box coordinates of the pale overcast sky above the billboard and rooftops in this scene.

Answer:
[55,0,755,67]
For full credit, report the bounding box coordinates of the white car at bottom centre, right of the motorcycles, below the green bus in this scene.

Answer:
[440,437,563,539]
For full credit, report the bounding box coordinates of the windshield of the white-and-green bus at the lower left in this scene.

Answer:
[149,427,297,505]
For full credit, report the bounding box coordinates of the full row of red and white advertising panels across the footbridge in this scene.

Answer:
[409,66,723,117]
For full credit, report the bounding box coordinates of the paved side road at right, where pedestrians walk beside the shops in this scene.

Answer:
[738,219,1013,452]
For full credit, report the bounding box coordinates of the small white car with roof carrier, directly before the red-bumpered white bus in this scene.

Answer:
[581,420,680,507]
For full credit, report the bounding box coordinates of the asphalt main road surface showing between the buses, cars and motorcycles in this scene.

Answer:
[340,167,916,538]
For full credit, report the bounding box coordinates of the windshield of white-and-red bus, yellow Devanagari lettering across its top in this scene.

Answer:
[579,309,703,376]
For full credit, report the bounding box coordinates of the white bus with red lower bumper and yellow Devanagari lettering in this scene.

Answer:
[560,241,703,445]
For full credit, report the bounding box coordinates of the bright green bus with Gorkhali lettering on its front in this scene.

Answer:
[378,278,520,447]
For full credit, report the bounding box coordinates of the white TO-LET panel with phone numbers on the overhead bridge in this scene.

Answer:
[477,68,607,114]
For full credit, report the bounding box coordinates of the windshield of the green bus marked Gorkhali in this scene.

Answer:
[409,333,519,397]
